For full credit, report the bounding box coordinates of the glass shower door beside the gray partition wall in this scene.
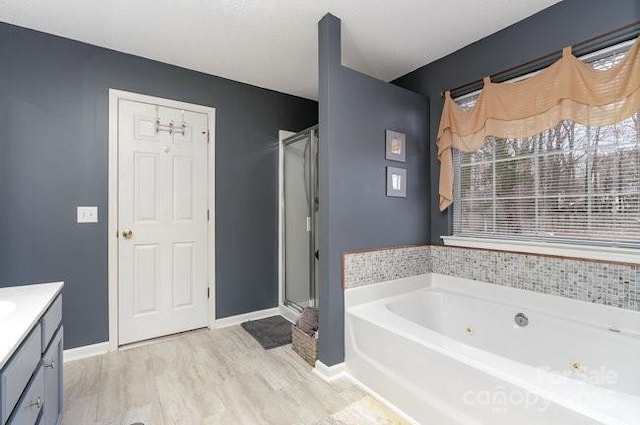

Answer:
[283,127,317,310]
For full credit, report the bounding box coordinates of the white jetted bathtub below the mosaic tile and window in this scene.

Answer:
[345,274,640,425]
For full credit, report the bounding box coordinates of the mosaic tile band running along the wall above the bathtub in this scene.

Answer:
[343,245,640,311]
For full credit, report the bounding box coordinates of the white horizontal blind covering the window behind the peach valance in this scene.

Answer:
[453,47,640,246]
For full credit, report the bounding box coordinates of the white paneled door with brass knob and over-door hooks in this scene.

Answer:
[118,99,209,345]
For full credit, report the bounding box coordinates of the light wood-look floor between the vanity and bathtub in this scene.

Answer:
[63,326,404,425]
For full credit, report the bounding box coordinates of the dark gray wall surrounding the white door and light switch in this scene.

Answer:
[0,23,317,348]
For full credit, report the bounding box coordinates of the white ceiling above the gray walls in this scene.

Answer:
[0,0,559,99]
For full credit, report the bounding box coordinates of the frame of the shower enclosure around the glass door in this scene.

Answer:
[278,125,319,319]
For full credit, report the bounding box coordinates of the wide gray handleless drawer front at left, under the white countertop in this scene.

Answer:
[0,323,42,424]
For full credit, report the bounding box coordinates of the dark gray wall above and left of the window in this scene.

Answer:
[394,0,640,244]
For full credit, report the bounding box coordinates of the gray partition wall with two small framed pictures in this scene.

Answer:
[319,15,429,365]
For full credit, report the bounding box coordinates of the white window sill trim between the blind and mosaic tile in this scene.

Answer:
[442,236,640,264]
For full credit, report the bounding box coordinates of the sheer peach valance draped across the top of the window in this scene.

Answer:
[437,39,640,211]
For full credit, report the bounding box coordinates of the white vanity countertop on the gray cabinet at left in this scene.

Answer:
[0,282,64,369]
